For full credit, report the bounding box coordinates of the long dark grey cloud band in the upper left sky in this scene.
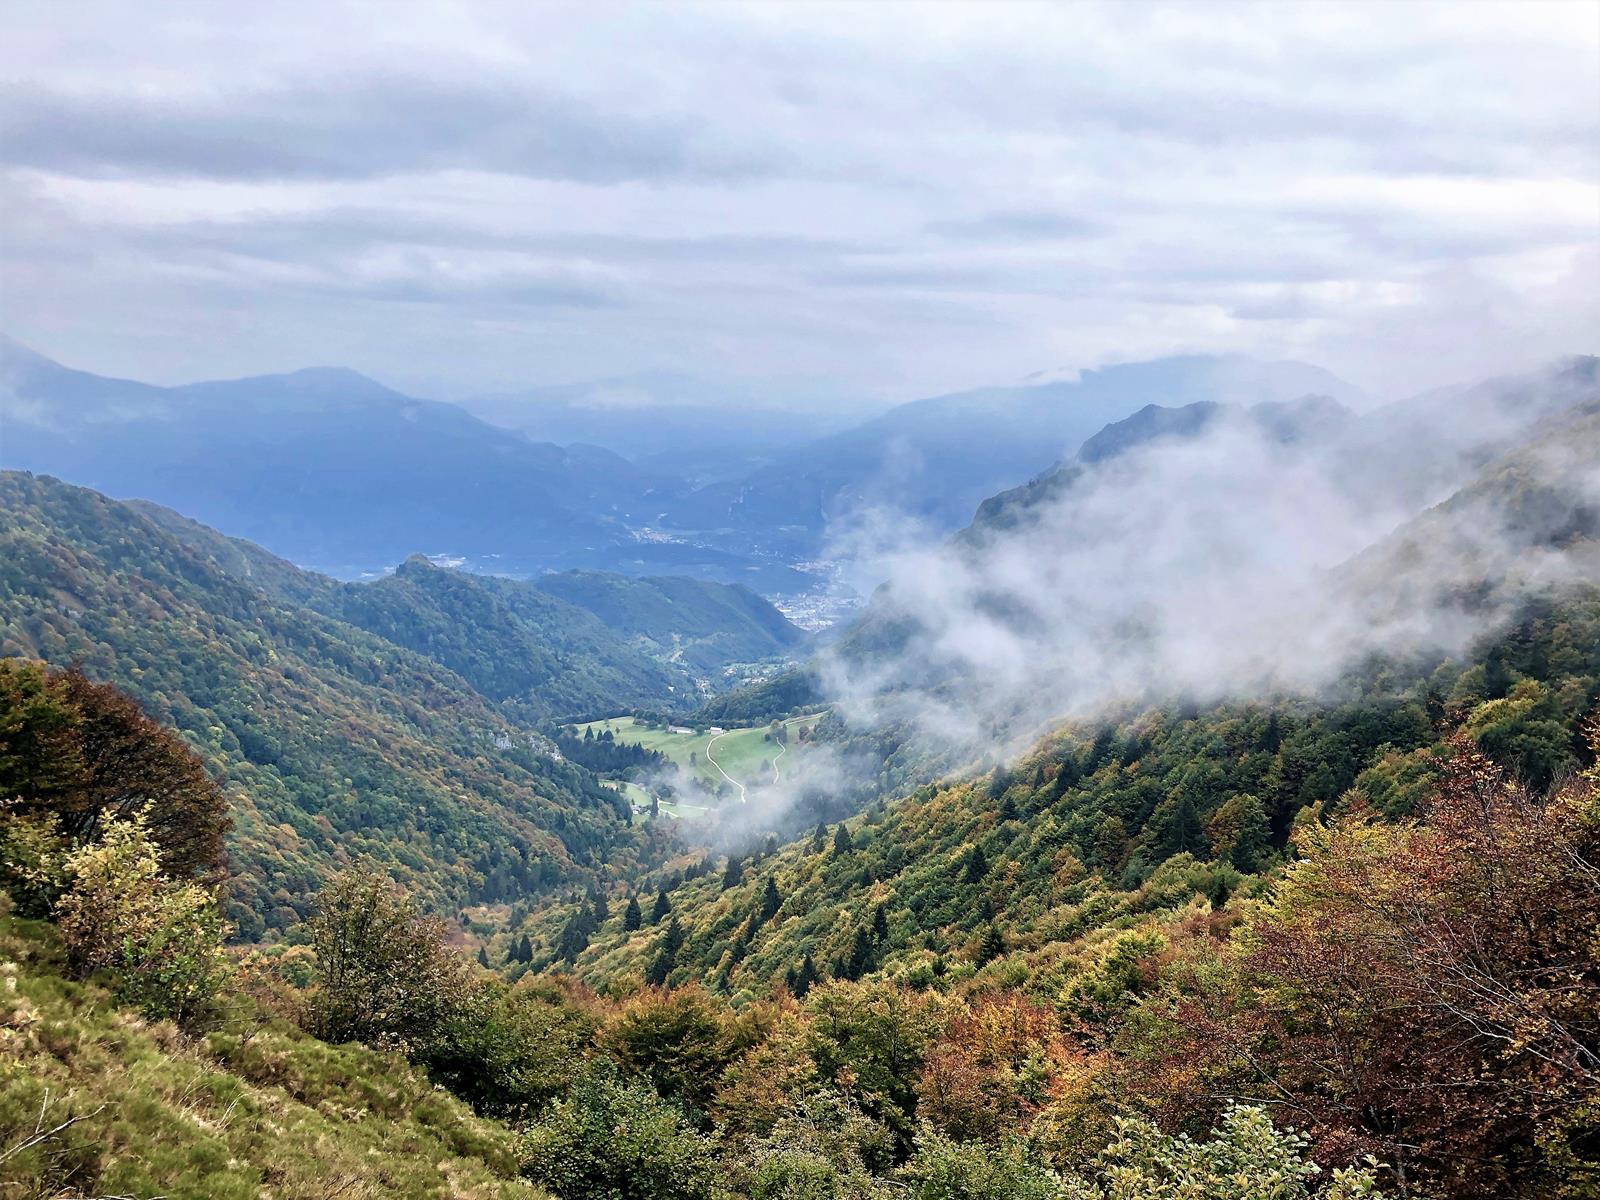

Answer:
[0,77,776,184]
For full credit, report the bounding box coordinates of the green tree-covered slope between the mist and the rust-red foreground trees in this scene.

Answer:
[518,586,1600,995]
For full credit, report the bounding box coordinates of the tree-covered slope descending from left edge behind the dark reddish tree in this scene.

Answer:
[0,472,632,939]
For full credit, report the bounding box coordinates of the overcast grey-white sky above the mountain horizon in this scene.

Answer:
[0,0,1600,402]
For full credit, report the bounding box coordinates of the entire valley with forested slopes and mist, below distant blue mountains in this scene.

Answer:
[0,347,1600,1200]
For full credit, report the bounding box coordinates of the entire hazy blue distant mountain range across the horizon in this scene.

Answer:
[0,339,1362,595]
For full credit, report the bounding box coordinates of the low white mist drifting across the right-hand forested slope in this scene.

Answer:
[812,370,1600,757]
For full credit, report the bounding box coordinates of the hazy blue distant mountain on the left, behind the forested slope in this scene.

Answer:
[0,341,838,590]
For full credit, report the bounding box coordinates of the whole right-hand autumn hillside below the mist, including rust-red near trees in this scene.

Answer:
[491,586,1600,1200]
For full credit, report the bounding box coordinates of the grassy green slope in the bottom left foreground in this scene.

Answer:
[0,918,544,1200]
